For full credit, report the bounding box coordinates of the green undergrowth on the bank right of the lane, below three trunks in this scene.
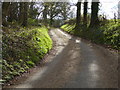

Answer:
[61,20,120,50]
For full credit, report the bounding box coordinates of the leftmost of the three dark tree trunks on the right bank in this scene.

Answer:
[75,2,81,29]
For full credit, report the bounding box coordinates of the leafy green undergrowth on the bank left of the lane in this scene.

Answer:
[2,27,52,82]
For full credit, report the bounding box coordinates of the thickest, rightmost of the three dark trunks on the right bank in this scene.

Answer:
[90,0,99,27]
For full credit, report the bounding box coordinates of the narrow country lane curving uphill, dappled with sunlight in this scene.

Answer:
[4,29,118,89]
